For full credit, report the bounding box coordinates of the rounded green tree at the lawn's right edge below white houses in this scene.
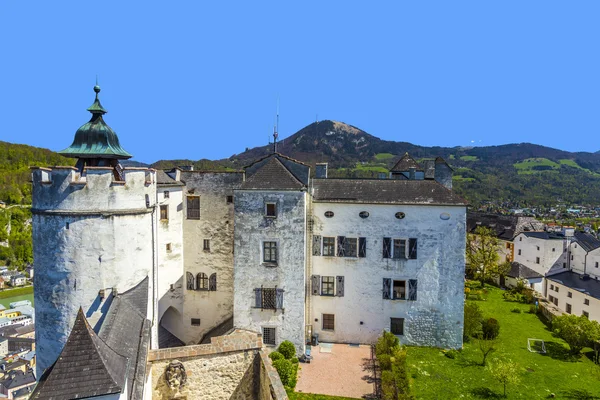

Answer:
[552,315,600,354]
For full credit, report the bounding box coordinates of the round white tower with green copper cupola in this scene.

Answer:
[32,85,157,377]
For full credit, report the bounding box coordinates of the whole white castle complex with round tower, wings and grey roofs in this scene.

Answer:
[32,86,466,399]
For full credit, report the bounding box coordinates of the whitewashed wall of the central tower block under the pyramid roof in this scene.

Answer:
[233,190,307,354]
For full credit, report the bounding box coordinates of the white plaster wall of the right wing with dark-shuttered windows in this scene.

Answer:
[308,203,466,348]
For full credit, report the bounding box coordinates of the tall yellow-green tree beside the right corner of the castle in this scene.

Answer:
[467,226,506,287]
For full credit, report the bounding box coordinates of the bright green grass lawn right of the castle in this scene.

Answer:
[407,286,600,399]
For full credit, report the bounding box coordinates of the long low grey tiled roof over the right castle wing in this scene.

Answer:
[312,178,467,206]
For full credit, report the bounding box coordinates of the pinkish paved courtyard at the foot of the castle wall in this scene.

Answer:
[296,343,373,398]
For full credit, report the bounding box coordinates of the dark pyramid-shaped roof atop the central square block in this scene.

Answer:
[242,155,305,190]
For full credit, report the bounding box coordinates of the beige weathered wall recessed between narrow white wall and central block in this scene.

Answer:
[179,171,243,344]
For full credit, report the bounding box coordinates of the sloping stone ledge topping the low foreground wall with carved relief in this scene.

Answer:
[148,330,262,361]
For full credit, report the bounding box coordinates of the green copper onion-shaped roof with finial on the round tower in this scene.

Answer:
[58,85,132,159]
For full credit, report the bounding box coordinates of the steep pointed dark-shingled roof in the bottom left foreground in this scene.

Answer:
[30,308,127,400]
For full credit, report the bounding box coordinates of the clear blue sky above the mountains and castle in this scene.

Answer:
[0,0,600,162]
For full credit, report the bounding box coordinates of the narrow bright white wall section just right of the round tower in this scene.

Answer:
[156,186,185,336]
